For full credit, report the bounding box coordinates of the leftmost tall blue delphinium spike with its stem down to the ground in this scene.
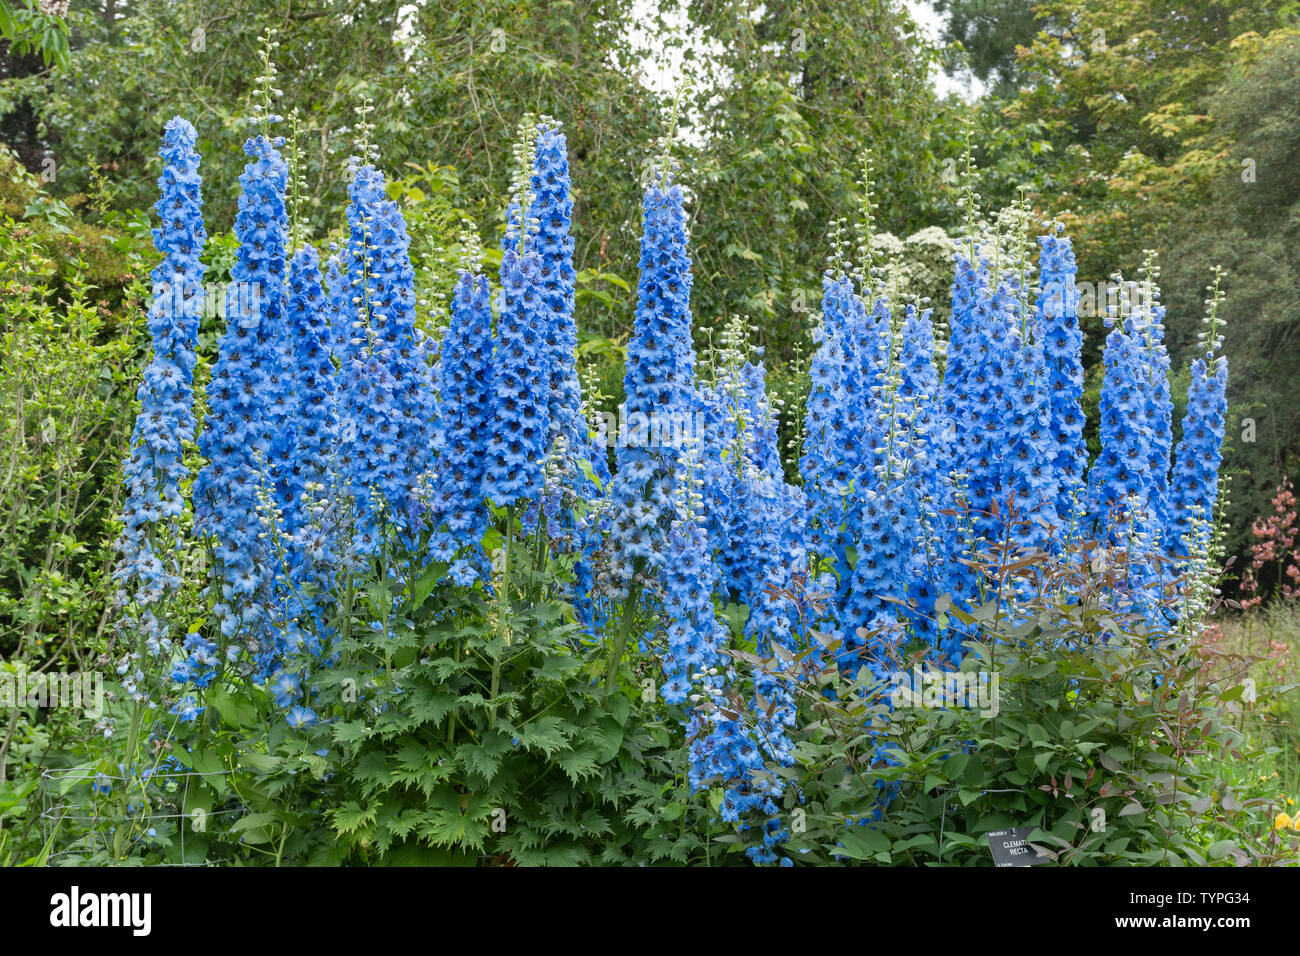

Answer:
[74,117,215,860]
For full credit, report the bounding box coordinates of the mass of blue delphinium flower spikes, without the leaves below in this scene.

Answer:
[124,111,1237,864]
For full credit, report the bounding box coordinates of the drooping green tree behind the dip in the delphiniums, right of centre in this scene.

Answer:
[686,0,961,360]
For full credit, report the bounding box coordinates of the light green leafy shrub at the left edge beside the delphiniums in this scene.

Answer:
[0,219,142,806]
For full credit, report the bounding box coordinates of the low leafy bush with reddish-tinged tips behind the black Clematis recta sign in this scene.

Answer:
[738,554,1286,866]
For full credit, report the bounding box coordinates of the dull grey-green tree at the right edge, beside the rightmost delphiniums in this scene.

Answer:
[1164,29,1300,564]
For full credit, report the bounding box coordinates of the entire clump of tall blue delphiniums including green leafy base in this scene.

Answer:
[76,55,1251,865]
